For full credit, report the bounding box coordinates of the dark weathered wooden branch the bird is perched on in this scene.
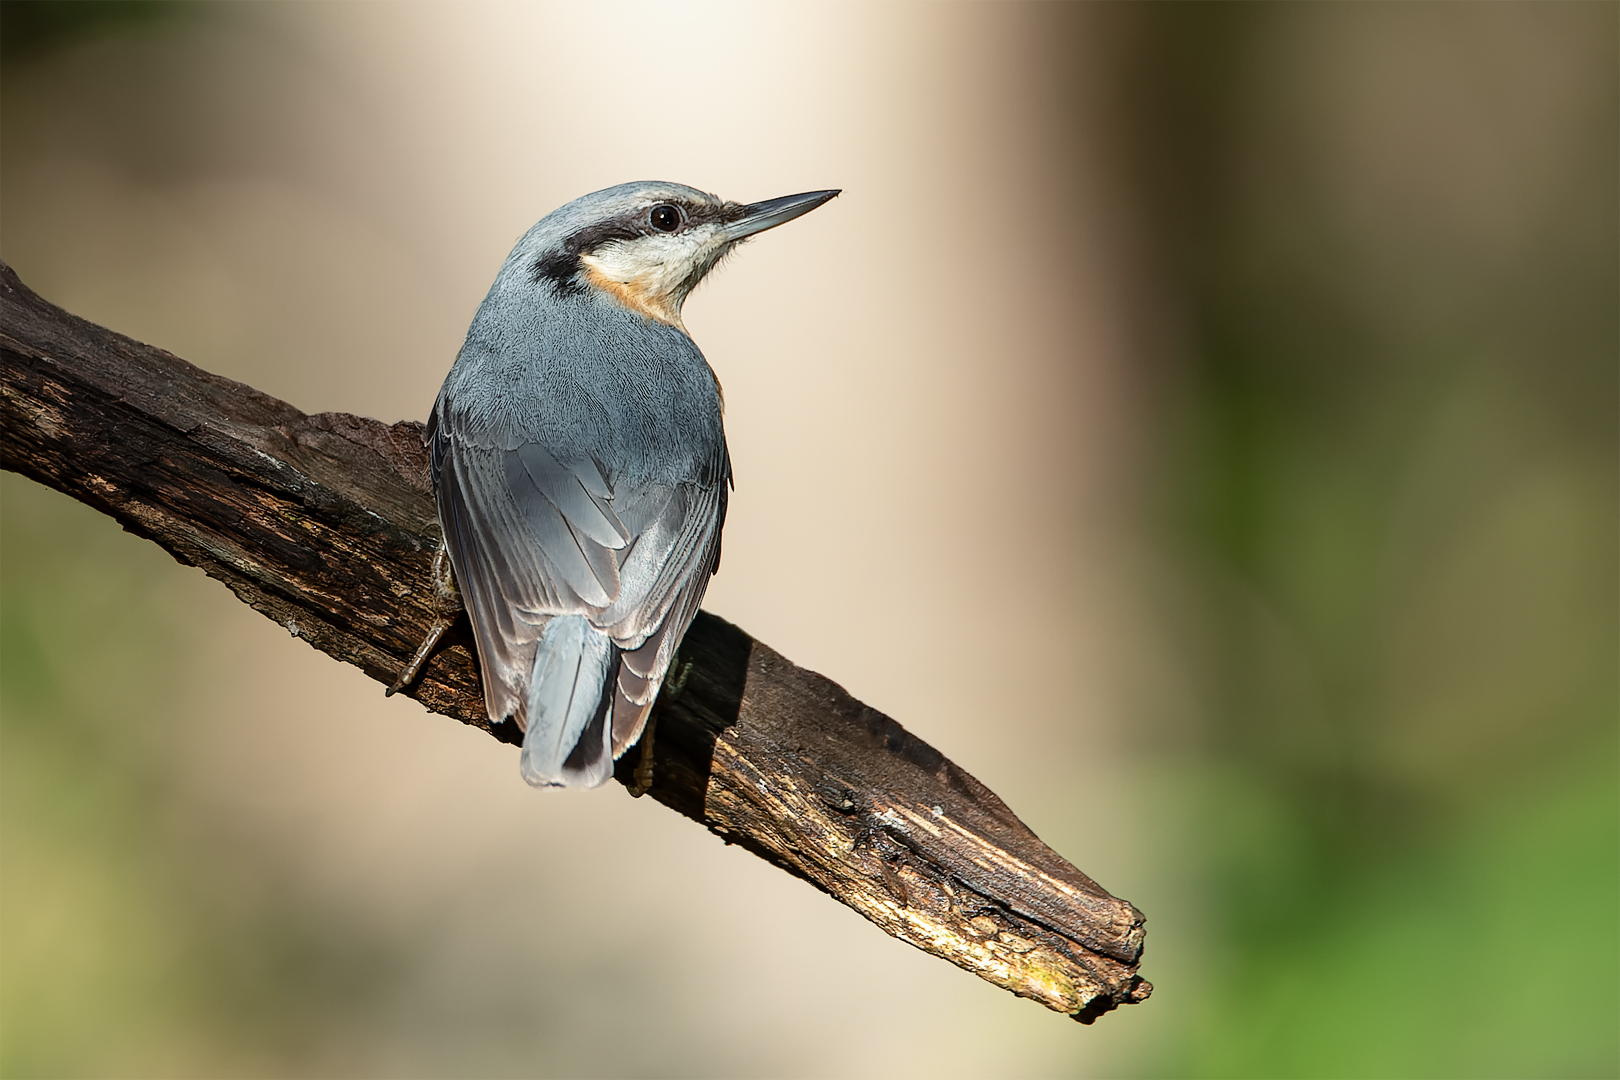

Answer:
[0,264,1152,1022]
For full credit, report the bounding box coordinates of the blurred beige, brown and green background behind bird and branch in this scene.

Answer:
[0,0,1620,1077]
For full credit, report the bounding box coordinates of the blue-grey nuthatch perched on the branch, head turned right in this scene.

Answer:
[405,181,839,789]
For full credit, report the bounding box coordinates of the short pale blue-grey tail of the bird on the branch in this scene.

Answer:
[522,615,619,787]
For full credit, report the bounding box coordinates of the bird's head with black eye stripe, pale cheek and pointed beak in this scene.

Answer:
[509,181,838,327]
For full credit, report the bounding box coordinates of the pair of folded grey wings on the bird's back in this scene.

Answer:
[429,401,731,756]
